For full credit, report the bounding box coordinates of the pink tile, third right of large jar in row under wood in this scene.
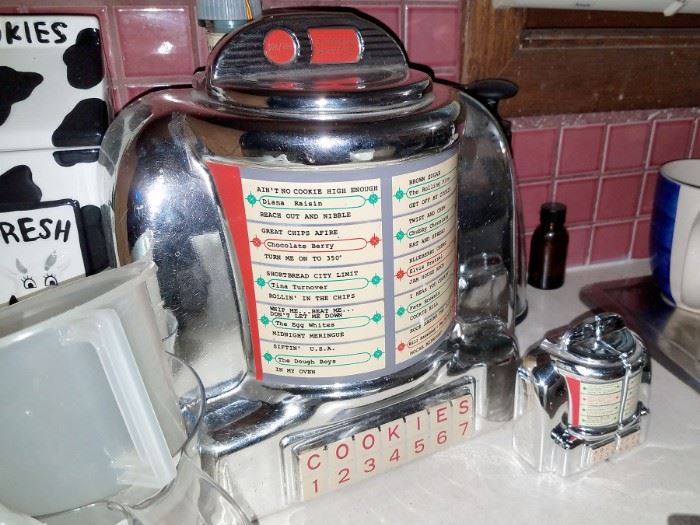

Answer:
[605,122,651,171]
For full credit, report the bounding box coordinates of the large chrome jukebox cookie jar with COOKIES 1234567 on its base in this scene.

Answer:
[102,11,518,516]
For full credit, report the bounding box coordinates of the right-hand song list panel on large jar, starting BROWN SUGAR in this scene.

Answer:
[392,156,457,363]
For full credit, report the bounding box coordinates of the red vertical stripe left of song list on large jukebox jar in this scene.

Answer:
[207,162,263,381]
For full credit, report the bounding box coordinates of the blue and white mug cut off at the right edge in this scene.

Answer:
[651,159,700,313]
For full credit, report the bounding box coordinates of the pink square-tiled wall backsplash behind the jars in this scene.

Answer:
[0,0,700,266]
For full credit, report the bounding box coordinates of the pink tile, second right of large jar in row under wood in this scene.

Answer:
[558,125,605,175]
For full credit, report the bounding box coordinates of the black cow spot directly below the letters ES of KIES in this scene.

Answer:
[63,29,104,89]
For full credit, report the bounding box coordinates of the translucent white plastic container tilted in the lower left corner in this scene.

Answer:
[0,262,186,516]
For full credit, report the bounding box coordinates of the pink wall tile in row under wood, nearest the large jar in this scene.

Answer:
[513,129,559,181]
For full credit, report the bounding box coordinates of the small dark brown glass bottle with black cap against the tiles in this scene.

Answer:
[527,202,569,290]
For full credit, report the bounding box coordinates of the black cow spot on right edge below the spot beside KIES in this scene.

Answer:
[51,98,108,148]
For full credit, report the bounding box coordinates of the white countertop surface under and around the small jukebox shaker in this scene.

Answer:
[262,261,700,525]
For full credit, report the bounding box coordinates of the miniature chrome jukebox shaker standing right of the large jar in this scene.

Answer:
[513,313,651,476]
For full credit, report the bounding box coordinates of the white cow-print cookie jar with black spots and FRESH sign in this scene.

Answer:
[0,15,111,305]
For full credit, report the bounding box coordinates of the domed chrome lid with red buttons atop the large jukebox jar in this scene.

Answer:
[200,11,433,120]
